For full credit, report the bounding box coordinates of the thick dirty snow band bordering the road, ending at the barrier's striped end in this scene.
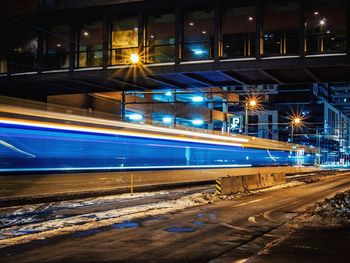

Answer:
[0,193,216,248]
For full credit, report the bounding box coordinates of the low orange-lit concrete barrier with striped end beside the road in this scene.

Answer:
[217,173,286,195]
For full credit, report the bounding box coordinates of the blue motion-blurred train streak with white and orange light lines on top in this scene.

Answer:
[0,117,314,172]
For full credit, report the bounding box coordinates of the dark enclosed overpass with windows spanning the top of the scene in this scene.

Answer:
[0,0,350,100]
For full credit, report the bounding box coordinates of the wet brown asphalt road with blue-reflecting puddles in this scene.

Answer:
[0,175,350,262]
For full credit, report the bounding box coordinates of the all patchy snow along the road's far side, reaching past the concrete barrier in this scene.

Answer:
[0,181,305,248]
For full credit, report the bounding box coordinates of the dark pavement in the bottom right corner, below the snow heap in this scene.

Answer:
[246,225,350,263]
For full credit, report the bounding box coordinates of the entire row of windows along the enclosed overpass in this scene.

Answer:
[1,0,347,72]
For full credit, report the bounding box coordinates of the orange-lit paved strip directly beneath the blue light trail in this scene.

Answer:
[0,167,317,207]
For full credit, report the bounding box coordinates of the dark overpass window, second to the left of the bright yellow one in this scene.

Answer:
[44,25,69,70]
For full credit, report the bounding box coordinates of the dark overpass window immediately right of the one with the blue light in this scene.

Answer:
[220,1,256,58]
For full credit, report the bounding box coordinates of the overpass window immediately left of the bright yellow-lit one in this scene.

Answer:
[77,22,103,68]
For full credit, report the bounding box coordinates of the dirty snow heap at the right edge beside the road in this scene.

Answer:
[309,191,350,224]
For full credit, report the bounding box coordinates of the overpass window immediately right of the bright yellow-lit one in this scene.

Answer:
[145,14,175,63]
